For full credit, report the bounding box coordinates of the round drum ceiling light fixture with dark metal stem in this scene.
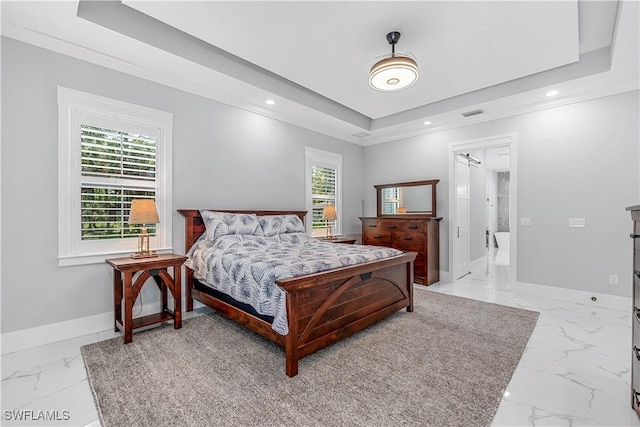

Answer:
[369,31,419,92]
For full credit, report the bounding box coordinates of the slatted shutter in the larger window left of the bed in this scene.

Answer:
[80,124,156,240]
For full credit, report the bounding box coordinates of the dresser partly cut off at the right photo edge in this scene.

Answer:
[627,205,640,415]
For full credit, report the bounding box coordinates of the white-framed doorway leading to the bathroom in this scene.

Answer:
[449,133,517,283]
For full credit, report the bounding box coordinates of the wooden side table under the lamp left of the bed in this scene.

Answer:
[105,254,187,344]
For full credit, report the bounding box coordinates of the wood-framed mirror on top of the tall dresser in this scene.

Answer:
[374,179,440,216]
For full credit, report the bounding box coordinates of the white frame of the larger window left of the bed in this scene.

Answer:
[58,86,173,267]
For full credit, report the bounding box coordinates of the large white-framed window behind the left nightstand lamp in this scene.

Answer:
[58,87,173,266]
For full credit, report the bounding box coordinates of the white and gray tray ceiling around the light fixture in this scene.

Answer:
[2,0,640,145]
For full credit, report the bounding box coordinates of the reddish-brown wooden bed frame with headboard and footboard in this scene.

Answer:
[178,209,416,377]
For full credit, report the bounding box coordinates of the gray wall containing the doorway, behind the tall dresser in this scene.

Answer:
[364,91,640,296]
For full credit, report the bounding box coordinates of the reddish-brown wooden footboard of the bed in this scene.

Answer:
[277,252,417,377]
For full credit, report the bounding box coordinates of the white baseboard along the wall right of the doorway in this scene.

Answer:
[511,282,633,312]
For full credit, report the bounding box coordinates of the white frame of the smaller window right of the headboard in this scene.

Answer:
[305,147,343,236]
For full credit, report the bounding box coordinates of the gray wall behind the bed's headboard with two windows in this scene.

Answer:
[1,38,364,333]
